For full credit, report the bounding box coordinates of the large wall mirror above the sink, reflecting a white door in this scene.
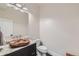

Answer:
[0,4,28,45]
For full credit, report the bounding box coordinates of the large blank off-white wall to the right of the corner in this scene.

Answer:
[40,4,79,55]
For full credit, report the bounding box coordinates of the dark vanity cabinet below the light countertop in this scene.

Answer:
[5,43,37,56]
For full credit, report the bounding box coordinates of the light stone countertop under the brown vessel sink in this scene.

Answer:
[0,40,37,56]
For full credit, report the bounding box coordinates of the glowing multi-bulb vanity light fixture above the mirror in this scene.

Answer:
[7,3,28,13]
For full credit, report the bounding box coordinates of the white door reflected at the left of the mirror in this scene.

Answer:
[0,18,13,44]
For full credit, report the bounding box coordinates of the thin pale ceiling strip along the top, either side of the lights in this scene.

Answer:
[0,3,79,10]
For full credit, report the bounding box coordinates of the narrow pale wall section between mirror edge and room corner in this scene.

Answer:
[26,4,40,39]
